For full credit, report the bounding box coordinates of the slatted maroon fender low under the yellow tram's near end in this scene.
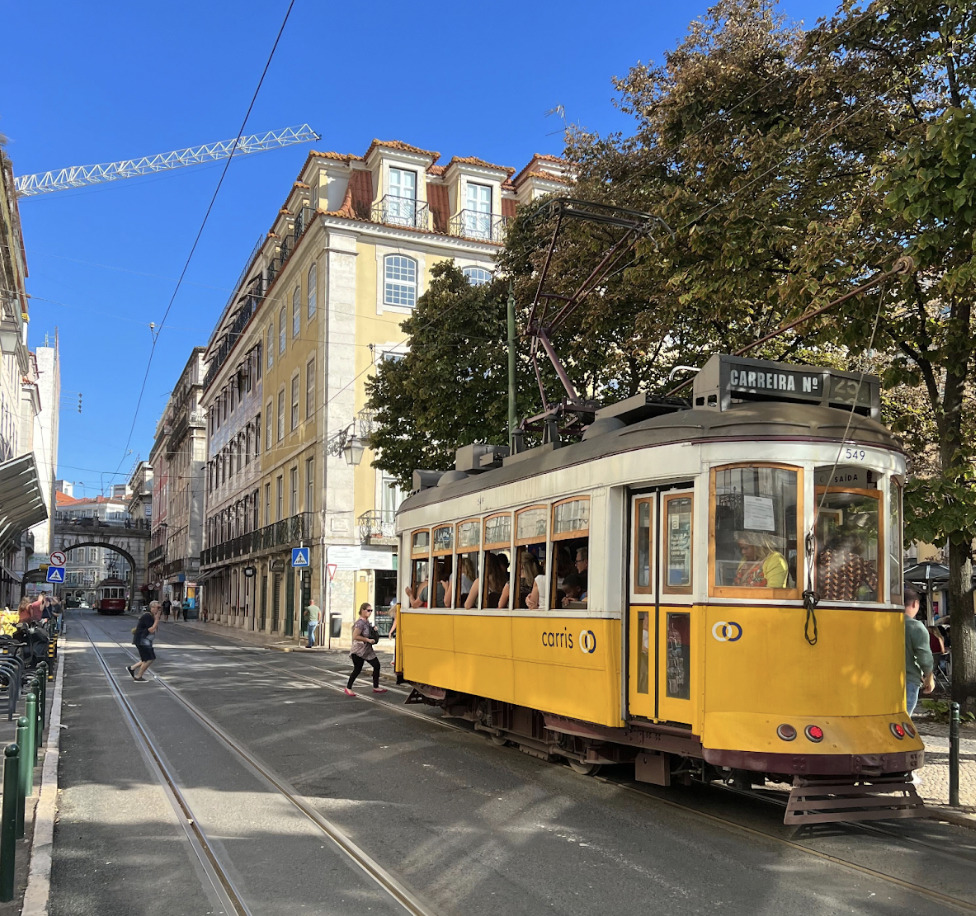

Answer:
[783,779,925,824]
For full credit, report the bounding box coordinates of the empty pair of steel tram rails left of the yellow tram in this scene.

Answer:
[79,621,437,916]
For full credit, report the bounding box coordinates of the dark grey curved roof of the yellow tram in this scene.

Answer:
[401,402,903,509]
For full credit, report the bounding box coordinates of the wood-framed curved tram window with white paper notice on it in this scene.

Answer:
[711,465,799,588]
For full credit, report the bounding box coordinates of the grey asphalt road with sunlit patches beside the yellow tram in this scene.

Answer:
[50,612,976,916]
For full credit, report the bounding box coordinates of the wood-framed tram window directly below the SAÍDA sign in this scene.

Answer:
[816,487,883,601]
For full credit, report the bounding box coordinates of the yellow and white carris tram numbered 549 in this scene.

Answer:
[396,356,923,822]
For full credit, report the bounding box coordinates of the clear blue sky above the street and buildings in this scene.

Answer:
[0,0,836,496]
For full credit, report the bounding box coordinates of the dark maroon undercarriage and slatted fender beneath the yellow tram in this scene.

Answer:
[406,684,925,825]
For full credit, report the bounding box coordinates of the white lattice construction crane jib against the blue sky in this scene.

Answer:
[14,124,322,197]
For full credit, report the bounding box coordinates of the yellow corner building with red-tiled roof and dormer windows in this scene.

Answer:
[200,140,568,641]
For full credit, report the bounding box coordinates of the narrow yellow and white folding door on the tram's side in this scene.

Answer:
[627,484,695,723]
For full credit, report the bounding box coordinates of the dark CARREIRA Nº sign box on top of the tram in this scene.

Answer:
[694,355,881,419]
